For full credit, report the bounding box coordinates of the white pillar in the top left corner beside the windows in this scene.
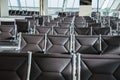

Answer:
[0,0,8,17]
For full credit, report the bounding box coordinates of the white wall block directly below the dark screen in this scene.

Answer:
[79,5,92,16]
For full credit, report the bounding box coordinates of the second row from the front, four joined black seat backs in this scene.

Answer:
[14,34,120,55]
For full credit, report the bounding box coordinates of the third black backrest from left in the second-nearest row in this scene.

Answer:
[74,35,100,54]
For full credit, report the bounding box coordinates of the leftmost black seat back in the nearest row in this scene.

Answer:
[0,53,28,80]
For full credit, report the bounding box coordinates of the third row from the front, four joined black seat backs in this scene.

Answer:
[36,26,112,35]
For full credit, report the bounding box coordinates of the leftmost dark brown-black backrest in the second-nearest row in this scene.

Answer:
[20,34,45,53]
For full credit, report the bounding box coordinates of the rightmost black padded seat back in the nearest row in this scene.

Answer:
[78,55,120,80]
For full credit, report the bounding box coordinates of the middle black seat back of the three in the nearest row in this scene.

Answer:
[30,54,74,80]
